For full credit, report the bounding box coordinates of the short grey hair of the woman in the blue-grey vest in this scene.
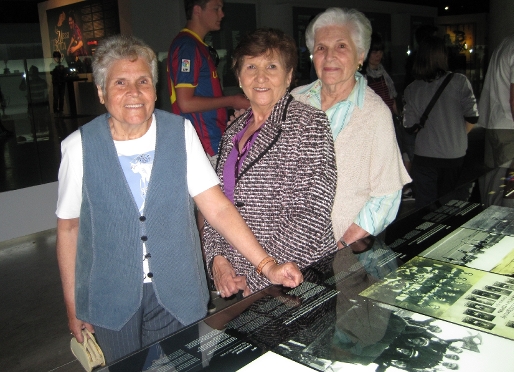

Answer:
[93,35,159,94]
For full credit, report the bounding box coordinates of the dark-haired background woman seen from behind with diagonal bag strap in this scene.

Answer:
[403,36,478,208]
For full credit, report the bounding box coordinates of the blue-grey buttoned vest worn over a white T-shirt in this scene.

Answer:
[75,110,208,330]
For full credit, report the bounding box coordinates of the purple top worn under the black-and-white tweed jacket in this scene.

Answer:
[223,114,262,203]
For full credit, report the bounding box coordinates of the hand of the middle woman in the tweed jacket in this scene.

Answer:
[212,256,251,297]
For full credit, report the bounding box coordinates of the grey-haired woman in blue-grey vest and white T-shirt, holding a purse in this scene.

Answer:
[56,36,302,363]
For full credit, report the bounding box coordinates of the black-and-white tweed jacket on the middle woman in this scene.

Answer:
[203,93,337,291]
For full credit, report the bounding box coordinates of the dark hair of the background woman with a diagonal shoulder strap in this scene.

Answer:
[412,36,448,81]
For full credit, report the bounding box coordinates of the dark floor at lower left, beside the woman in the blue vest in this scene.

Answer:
[0,230,82,371]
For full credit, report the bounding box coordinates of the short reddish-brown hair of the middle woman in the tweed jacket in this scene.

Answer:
[232,28,298,77]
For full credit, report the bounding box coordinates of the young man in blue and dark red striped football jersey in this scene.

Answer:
[168,0,250,167]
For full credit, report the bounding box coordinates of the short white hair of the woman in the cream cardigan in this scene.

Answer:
[305,8,371,59]
